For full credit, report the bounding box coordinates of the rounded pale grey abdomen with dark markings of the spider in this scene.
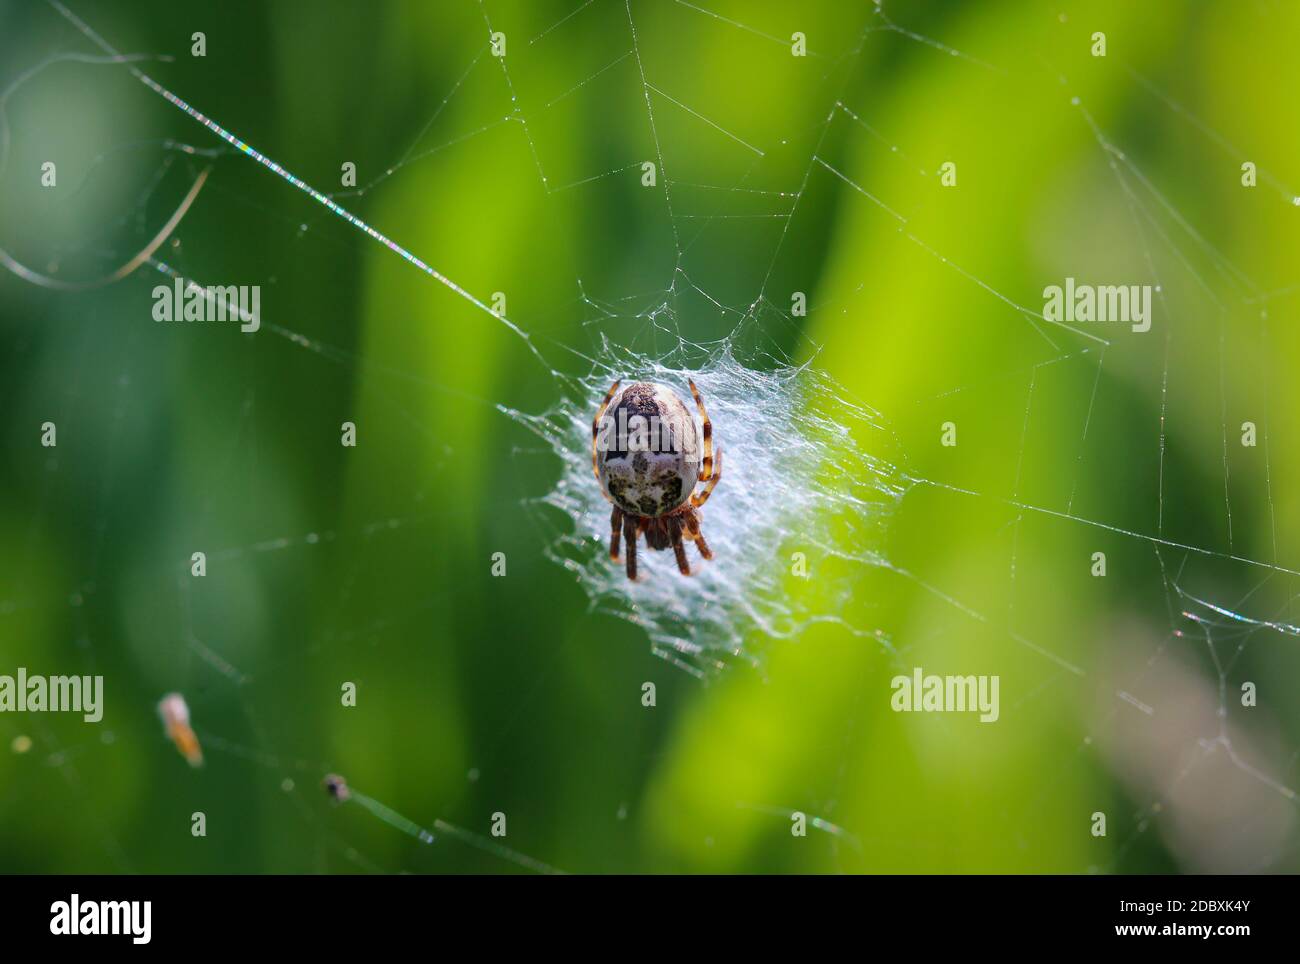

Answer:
[597,382,699,518]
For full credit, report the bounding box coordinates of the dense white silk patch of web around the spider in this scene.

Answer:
[507,335,902,676]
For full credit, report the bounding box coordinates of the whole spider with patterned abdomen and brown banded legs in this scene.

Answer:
[592,382,723,579]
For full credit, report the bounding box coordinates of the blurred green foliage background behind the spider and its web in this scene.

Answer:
[0,0,1300,873]
